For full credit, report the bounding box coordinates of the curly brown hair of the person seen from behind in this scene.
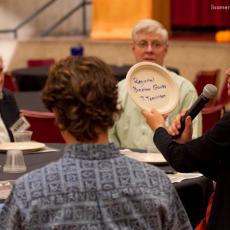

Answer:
[42,57,121,142]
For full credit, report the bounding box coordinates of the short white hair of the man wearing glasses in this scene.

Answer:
[132,19,168,43]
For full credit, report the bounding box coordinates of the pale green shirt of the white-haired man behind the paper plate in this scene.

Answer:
[109,71,202,150]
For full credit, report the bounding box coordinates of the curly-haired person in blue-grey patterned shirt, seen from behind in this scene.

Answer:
[0,57,192,230]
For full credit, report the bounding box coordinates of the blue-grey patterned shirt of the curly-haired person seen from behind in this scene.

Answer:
[0,143,192,230]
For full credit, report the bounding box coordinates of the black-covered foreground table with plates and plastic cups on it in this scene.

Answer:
[0,144,213,227]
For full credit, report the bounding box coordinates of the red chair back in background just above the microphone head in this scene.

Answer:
[193,69,220,95]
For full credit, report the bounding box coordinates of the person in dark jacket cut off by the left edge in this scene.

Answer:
[0,57,20,143]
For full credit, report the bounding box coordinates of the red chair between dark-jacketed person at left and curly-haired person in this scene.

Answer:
[20,110,64,143]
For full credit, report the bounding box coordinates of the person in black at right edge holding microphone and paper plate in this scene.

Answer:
[143,68,230,230]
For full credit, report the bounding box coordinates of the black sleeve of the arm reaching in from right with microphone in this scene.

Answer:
[153,113,230,179]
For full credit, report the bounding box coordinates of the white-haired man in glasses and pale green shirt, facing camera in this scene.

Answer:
[109,19,202,149]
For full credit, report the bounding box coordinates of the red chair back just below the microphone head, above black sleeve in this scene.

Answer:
[202,104,224,133]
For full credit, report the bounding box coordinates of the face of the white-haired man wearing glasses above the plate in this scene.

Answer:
[132,32,168,65]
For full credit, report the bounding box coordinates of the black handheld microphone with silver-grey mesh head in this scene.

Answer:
[172,84,217,139]
